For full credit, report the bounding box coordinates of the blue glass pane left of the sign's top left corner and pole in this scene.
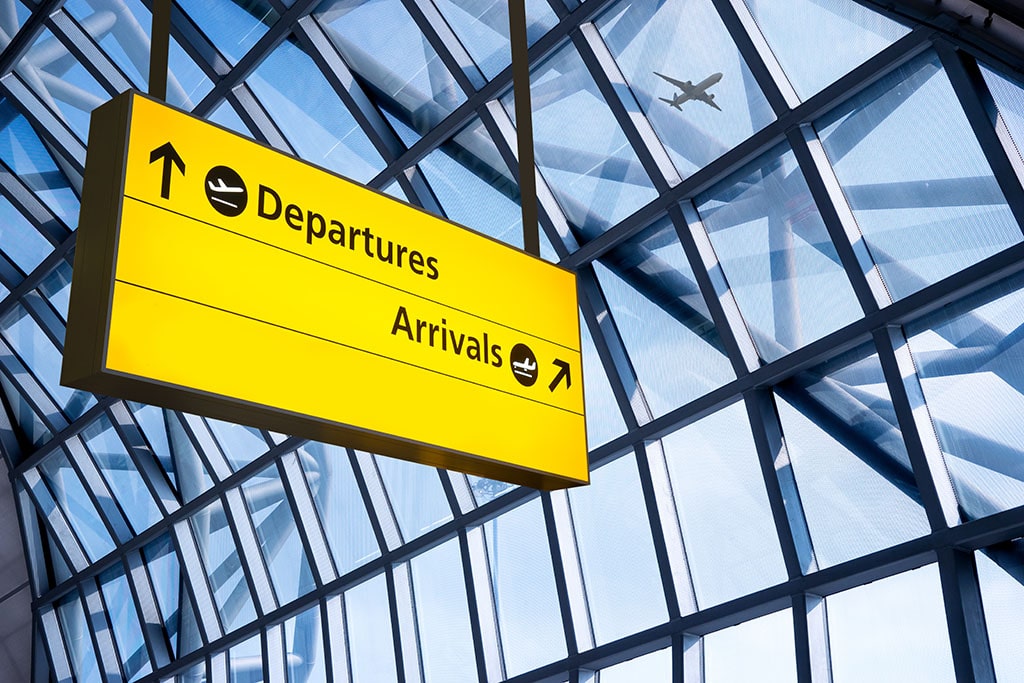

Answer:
[14,29,110,141]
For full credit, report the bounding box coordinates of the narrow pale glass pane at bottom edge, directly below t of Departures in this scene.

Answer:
[345,574,398,683]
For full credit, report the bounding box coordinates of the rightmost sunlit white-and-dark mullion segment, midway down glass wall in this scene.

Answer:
[873,327,959,530]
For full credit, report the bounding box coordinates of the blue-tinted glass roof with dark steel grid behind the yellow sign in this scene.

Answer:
[6,0,1024,683]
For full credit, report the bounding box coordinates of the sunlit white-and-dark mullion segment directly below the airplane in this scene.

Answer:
[669,202,761,377]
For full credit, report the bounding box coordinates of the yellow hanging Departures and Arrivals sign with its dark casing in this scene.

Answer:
[61,92,588,488]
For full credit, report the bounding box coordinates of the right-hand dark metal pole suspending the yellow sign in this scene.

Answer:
[509,0,541,256]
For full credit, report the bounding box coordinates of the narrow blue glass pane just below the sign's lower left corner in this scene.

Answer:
[82,416,163,533]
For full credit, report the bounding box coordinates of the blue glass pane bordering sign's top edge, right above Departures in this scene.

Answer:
[246,38,384,182]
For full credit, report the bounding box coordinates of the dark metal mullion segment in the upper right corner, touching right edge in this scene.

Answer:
[935,40,1024,231]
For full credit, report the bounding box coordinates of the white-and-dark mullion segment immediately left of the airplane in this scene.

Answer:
[571,23,682,195]
